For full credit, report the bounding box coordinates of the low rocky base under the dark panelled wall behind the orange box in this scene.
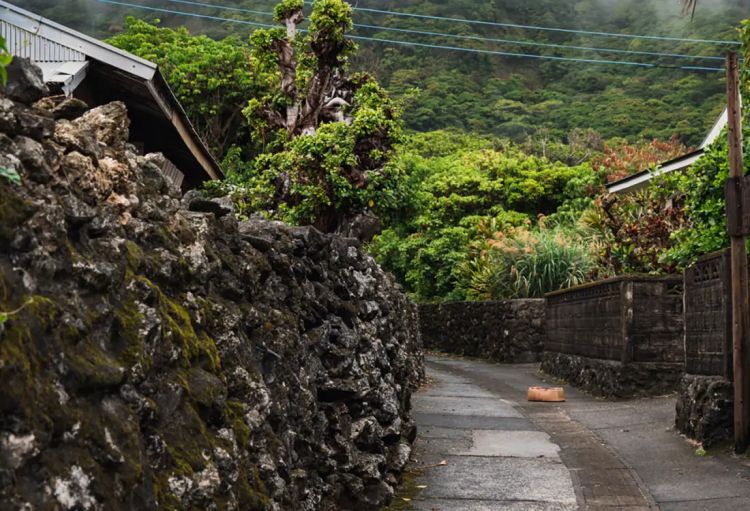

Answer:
[541,351,683,398]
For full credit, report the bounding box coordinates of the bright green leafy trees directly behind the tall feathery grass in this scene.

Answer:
[371,131,601,300]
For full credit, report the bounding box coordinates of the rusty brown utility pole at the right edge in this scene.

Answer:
[726,52,750,454]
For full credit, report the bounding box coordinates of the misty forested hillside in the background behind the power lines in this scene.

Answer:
[21,0,747,145]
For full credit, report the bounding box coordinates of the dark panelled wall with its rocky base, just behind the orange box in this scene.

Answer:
[541,275,685,397]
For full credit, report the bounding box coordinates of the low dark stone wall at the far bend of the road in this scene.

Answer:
[419,299,545,362]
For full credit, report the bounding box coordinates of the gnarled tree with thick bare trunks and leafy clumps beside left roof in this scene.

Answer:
[227,0,402,237]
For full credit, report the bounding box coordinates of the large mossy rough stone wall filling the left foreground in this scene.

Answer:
[0,61,422,510]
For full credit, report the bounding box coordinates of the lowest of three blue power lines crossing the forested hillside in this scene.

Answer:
[91,0,724,71]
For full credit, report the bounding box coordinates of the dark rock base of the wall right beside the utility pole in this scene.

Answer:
[675,374,734,448]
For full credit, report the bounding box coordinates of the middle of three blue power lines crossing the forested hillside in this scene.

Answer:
[159,0,724,62]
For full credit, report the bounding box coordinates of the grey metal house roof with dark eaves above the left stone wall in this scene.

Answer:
[0,0,222,186]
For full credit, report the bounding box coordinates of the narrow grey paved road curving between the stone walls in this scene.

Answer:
[406,356,750,511]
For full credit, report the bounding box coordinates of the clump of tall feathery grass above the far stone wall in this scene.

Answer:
[464,228,597,300]
